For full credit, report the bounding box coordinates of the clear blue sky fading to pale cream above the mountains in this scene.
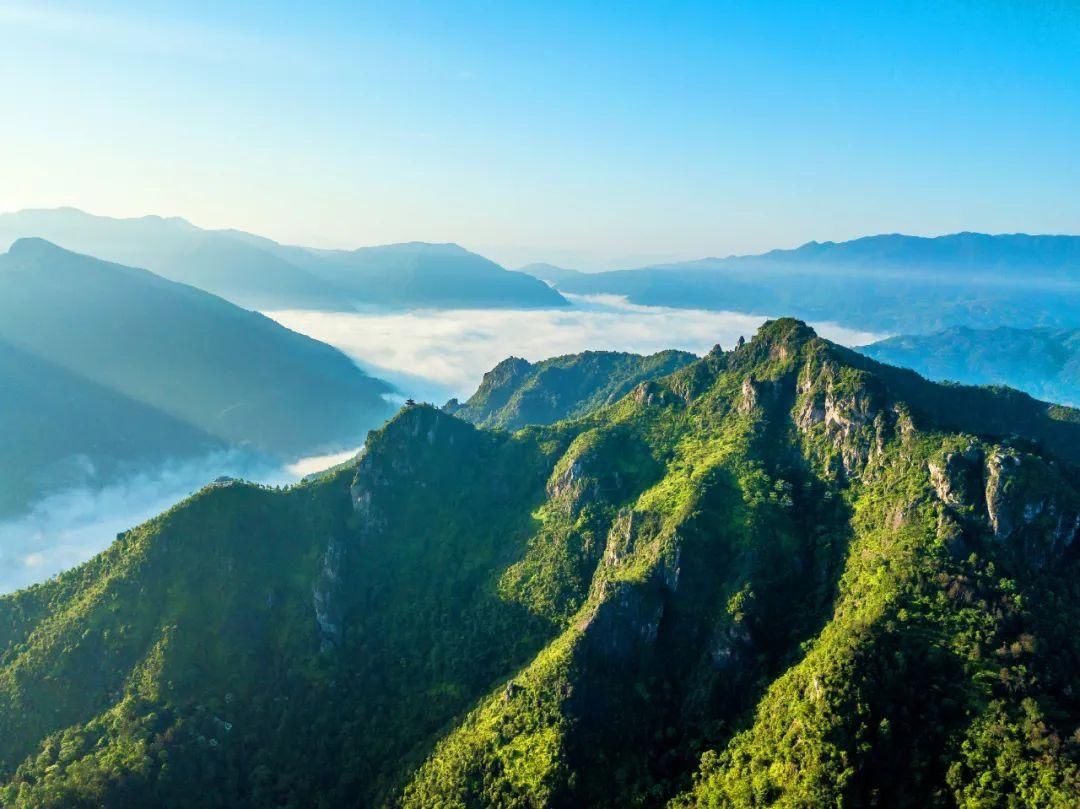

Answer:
[0,0,1080,268]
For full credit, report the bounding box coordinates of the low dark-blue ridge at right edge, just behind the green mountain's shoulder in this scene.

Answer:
[859,326,1080,406]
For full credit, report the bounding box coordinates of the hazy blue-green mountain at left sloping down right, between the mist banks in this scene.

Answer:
[0,239,391,514]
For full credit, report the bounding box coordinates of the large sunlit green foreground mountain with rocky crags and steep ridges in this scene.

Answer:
[0,320,1080,807]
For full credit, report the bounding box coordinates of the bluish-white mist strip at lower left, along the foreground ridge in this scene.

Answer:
[0,442,357,594]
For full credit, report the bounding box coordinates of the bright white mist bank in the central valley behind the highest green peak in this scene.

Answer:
[265,296,886,404]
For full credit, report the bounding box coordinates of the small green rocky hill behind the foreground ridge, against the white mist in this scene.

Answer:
[444,351,698,430]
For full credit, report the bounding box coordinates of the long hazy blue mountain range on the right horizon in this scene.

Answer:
[555,233,1080,332]
